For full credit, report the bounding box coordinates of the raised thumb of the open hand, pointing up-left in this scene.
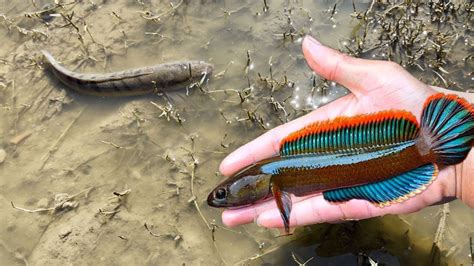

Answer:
[303,36,381,96]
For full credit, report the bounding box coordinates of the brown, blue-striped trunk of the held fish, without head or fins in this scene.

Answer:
[261,141,429,196]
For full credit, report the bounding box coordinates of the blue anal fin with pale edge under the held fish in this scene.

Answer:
[323,164,438,207]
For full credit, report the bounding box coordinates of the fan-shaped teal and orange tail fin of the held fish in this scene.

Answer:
[420,93,474,165]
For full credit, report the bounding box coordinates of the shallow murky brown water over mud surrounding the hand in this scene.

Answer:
[0,0,474,265]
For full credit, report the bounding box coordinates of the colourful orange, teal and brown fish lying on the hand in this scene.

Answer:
[207,93,474,232]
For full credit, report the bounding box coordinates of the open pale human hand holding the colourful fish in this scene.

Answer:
[220,36,474,231]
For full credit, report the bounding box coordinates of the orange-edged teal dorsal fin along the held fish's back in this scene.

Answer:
[280,110,419,156]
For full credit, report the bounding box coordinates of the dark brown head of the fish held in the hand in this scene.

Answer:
[207,166,271,207]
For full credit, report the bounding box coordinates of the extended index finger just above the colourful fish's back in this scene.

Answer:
[219,94,357,176]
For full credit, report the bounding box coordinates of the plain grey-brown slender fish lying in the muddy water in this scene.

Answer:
[42,50,214,96]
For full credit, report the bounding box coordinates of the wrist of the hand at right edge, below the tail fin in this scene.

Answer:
[454,150,474,208]
